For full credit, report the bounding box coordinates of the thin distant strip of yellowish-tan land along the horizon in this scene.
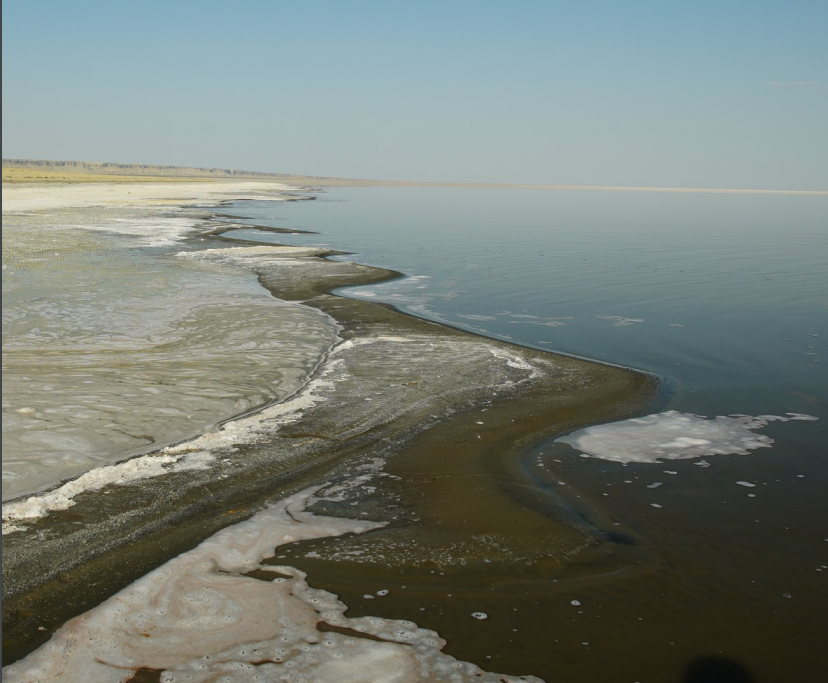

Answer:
[3,159,828,197]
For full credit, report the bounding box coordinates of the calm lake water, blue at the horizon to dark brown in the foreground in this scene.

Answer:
[220,188,828,681]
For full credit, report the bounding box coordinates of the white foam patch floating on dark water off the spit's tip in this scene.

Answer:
[556,410,818,466]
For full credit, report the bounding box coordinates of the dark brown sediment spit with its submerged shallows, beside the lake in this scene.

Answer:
[3,184,655,664]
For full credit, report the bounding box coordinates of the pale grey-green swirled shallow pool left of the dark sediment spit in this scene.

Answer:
[3,209,335,500]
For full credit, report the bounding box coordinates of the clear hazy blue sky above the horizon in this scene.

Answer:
[3,0,828,189]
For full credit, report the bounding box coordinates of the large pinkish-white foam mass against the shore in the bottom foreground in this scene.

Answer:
[3,487,539,683]
